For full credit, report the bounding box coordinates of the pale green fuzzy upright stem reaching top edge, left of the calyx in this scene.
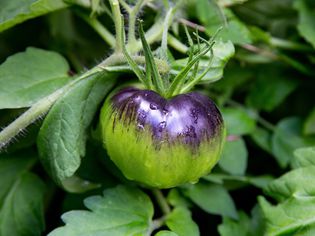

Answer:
[109,0,123,53]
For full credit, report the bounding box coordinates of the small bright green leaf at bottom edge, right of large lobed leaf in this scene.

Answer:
[166,207,200,236]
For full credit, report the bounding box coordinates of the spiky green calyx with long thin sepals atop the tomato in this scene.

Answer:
[121,18,221,98]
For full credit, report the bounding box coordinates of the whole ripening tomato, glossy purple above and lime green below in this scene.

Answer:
[100,87,225,188]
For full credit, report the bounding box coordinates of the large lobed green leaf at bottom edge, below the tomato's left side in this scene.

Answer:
[49,186,153,236]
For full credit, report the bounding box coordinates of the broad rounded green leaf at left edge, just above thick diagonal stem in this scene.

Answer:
[0,47,71,109]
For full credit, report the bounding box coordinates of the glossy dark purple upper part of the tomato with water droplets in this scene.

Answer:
[111,87,223,148]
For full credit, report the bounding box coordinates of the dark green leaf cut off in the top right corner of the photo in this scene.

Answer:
[294,0,315,48]
